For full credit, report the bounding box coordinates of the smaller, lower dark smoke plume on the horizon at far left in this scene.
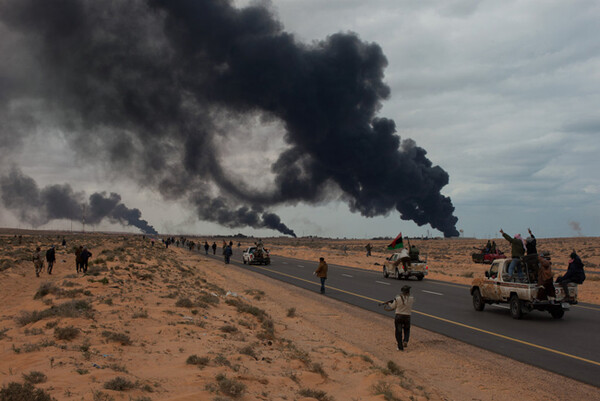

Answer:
[0,168,158,234]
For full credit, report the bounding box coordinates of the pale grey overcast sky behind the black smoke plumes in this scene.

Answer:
[0,0,600,238]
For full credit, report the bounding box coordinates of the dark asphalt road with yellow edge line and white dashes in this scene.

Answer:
[211,251,600,387]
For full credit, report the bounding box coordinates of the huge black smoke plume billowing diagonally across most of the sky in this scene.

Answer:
[0,0,458,236]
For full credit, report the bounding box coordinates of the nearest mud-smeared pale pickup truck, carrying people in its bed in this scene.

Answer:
[471,259,577,319]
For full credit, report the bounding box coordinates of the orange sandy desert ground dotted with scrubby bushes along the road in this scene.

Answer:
[0,234,600,401]
